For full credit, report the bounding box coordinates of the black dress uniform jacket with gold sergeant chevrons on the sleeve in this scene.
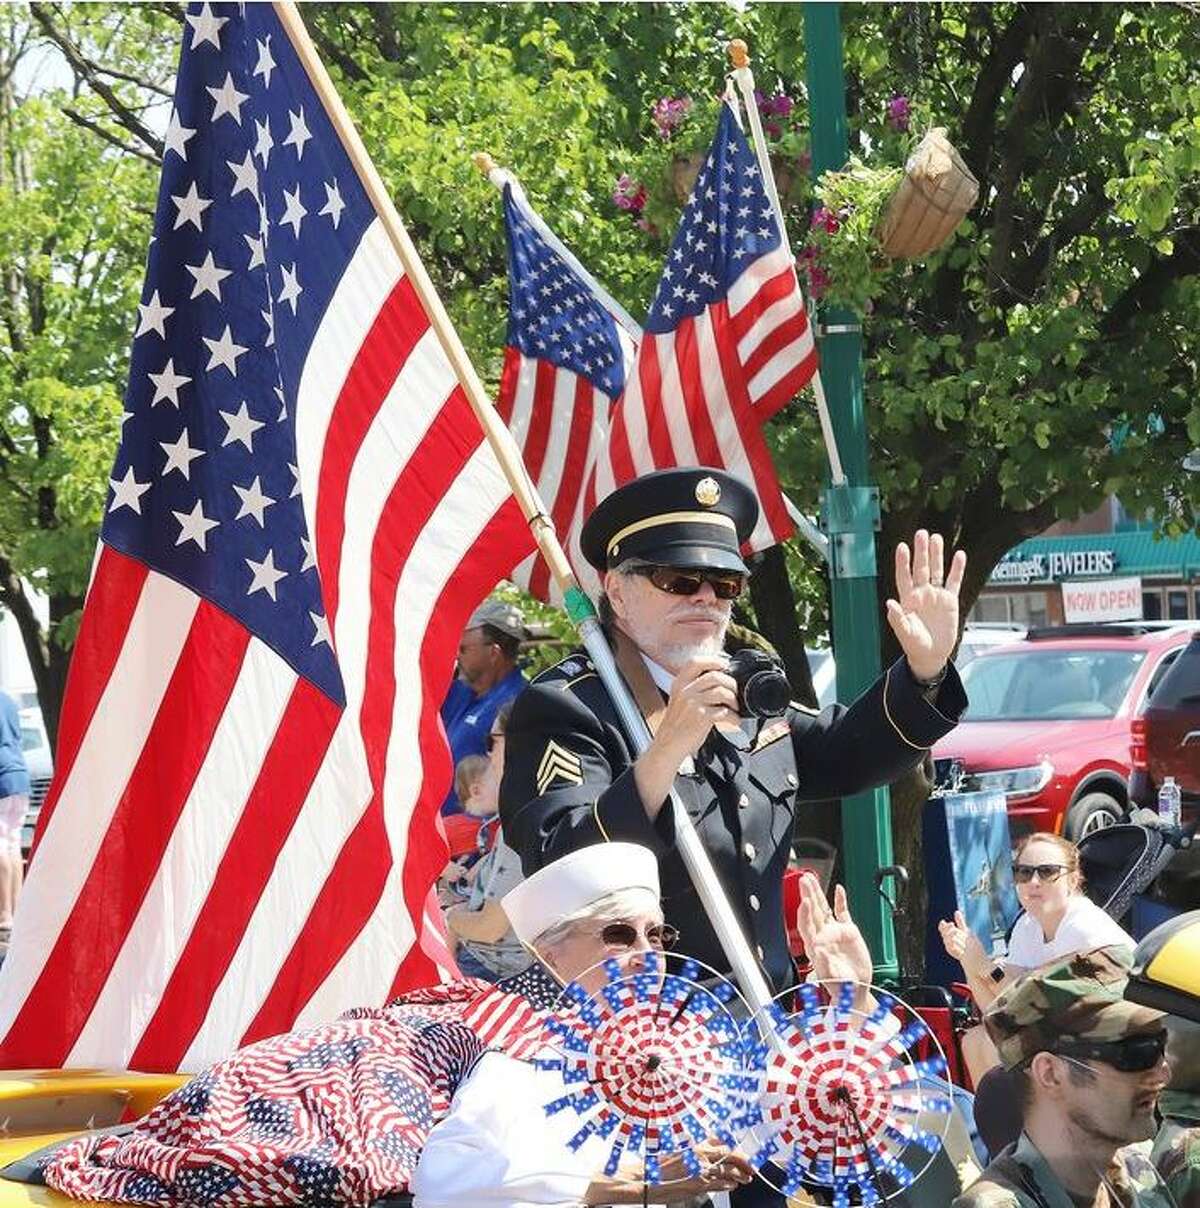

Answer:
[500,655,967,989]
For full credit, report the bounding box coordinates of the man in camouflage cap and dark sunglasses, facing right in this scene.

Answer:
[955,948,1171,1208]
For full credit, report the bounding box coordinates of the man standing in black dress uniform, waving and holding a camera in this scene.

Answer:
[500,467,967,989]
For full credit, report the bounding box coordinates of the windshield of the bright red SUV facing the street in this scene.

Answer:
[963,650,1146,721]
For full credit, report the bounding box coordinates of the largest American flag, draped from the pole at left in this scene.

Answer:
[0,4,532,1069]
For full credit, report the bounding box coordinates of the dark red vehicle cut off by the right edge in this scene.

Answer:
[1129,633,1200,819]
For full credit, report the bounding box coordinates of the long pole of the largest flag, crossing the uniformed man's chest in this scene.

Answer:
[273,0,771,1011]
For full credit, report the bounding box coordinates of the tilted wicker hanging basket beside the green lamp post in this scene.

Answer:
[880,127,979,260]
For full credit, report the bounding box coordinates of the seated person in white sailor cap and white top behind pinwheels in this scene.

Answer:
[410,843,753,1208]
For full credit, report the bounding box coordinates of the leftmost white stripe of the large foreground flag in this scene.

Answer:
[0,575,199,1035]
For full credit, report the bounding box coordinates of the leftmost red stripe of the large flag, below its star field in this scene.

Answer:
[34,545,149,852]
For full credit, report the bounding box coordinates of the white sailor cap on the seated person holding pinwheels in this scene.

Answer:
[500,843,659,943]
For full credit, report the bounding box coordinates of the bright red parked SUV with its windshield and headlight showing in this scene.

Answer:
[933,622,1194,840]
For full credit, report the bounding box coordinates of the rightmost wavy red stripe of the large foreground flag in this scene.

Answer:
[396,496,532,989]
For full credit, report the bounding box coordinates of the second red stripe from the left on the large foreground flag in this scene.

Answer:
[4,600,249,1065]
